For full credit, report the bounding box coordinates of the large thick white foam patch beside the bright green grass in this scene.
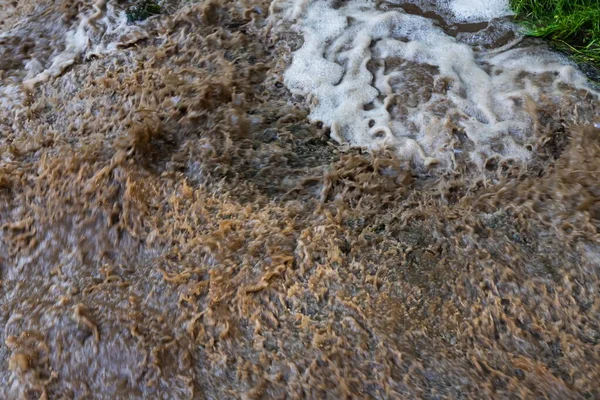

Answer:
[271,0,597,168]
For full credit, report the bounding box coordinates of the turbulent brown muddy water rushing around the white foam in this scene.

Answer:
[0,0,600,399]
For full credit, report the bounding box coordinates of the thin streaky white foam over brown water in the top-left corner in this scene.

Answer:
[0,0,147,108]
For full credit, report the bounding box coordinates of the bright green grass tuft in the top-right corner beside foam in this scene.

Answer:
[510,0,600,67]
